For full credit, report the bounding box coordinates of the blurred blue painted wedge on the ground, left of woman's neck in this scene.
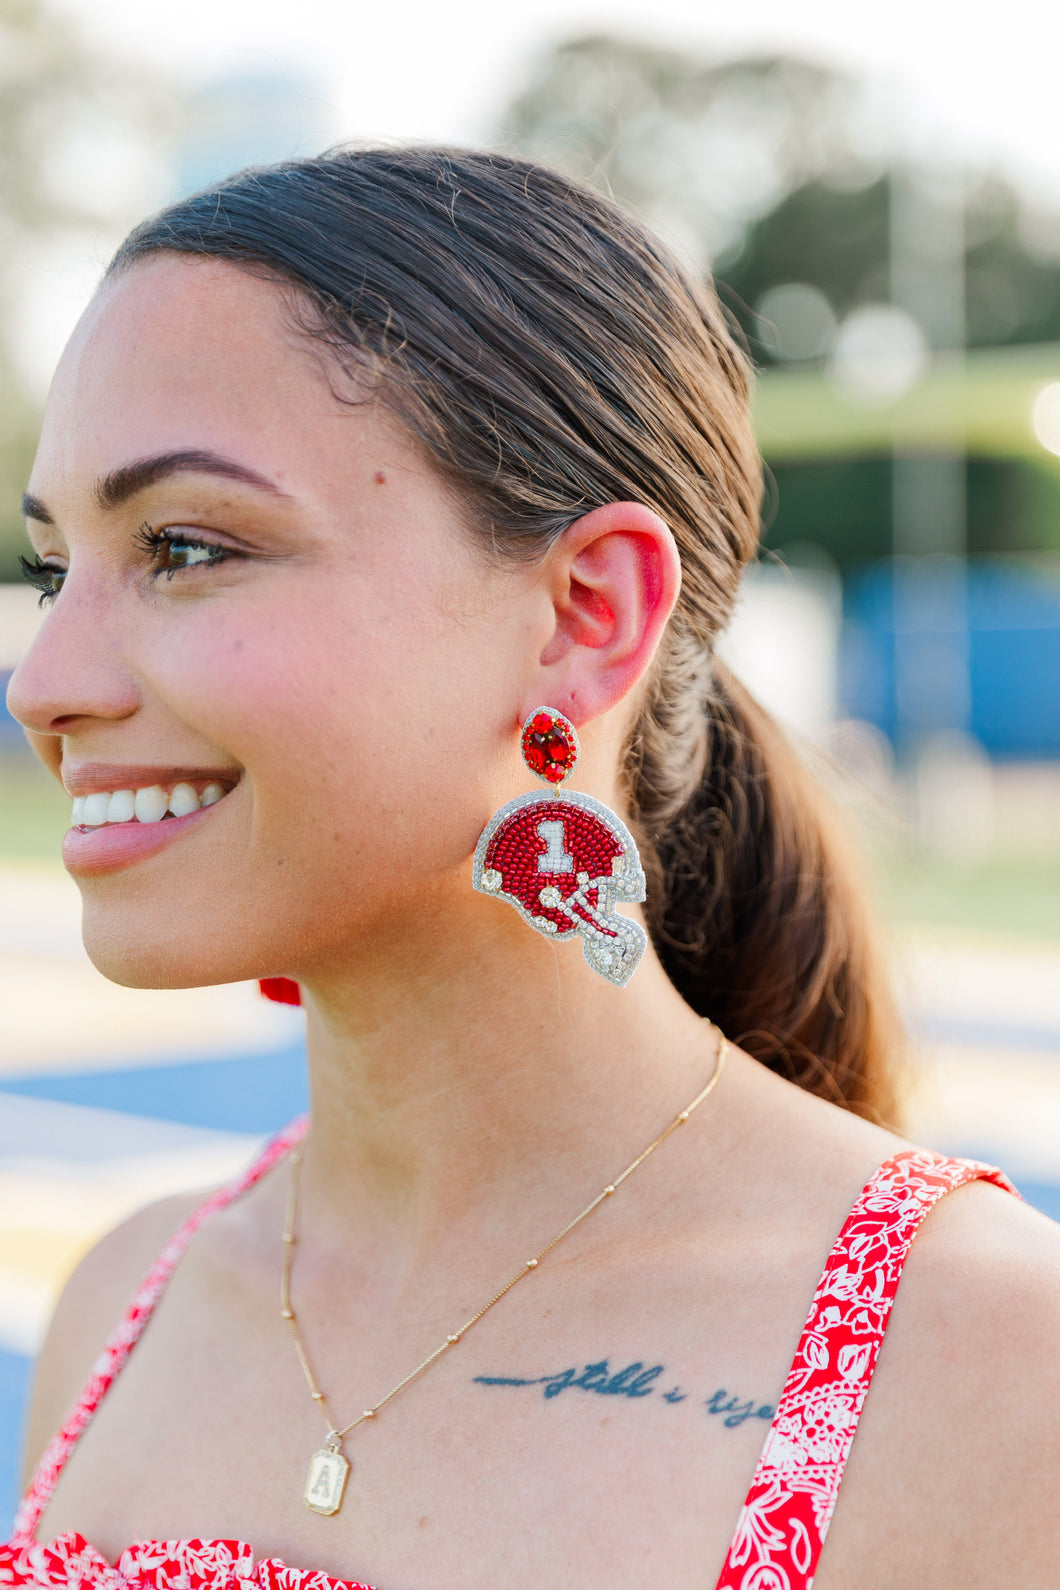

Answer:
[0,1043,308,1135]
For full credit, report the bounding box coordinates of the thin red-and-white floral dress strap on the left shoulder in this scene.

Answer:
[11,1116,308,1545]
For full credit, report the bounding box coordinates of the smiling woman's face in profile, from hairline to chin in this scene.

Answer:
[10,256,550,987]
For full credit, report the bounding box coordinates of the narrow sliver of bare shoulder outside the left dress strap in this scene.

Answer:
[25,1193,203,1476]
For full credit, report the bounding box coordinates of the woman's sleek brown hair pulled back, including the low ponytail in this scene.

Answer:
[111,149,893,1118]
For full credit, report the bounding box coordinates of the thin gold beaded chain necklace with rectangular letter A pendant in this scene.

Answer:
[280,1022,728,1517]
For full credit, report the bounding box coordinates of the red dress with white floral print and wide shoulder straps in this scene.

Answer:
[0,1121,1016,1590]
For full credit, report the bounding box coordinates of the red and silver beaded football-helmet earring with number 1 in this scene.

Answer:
[472,706,647,987]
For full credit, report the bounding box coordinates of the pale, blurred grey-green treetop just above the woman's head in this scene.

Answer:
[501,35,874,266]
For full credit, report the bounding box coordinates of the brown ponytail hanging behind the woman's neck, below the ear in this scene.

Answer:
[638,676,898,1124]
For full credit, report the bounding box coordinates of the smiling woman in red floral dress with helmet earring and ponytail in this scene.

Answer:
[0,149,1060,1590]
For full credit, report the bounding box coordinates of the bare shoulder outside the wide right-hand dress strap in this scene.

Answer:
[822,1163,1060,1590]
